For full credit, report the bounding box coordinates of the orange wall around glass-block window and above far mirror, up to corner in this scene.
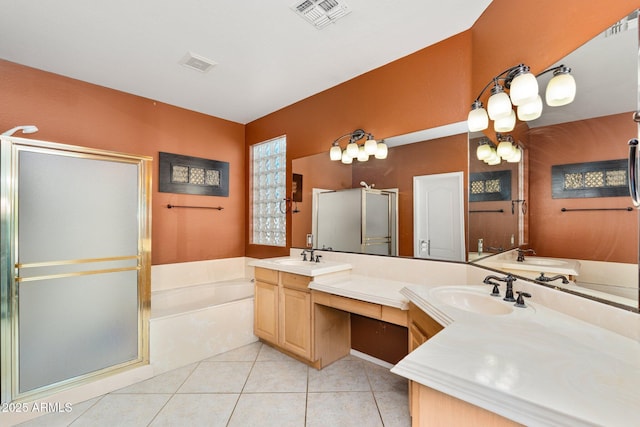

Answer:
[246,31,471,257]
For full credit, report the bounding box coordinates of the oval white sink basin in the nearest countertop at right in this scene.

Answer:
[431,286,513,316]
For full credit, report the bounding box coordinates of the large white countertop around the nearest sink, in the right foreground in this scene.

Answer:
[392,285,640,426]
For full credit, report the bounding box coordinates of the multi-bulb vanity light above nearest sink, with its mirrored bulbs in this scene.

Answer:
[467,64,576,132]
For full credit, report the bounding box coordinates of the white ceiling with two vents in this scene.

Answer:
[0,0,491,123]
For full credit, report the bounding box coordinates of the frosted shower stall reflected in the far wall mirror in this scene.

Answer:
[314,188,398,255]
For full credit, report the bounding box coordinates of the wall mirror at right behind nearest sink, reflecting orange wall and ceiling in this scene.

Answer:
[469,13,638,307]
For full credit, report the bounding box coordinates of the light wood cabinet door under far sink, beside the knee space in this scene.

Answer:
[280,288,311,360]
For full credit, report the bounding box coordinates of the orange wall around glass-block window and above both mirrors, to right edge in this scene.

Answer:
[245,0,640,257]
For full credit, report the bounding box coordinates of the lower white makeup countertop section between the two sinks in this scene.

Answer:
[309,274,411,310]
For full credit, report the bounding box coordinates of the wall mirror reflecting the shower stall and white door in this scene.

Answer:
[292,123,468,261]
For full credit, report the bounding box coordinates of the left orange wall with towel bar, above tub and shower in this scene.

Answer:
[0,60,246,264]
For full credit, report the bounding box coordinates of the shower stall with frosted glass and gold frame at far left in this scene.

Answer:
[0,136,151,403]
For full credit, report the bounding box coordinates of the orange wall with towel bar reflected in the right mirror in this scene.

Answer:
[529,113,638,264]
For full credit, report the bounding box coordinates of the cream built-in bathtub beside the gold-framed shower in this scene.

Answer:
[149,279,257,375]
